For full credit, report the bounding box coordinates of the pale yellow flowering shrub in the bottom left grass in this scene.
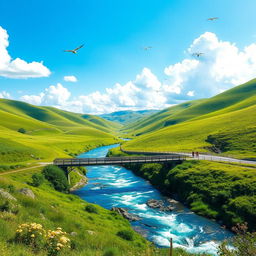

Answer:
[14,223,70,256]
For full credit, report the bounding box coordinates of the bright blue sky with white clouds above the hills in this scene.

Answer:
[0,0,256,114]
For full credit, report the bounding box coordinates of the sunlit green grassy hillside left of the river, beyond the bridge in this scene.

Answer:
[0,99,118,170]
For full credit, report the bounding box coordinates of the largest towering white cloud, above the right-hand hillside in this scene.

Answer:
[165,32,256,97]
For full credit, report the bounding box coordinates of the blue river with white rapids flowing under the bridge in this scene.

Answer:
[74,145,232,255]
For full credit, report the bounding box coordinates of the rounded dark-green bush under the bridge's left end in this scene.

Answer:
[42,165,69,192]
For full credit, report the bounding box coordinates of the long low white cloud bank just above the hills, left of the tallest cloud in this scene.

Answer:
[20,68,167,114]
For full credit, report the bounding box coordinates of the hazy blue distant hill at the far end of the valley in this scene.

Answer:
[99,110,158,124]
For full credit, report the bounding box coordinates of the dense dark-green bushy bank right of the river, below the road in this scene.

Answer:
[109,148,256,230]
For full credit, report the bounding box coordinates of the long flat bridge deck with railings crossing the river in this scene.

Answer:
[53,154,187,167]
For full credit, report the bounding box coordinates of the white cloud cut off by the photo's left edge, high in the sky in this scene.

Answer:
[0,26,51,78]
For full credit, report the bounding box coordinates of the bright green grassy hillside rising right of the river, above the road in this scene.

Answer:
[124,80,256,158]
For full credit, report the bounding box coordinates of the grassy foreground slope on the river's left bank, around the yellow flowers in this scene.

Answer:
[0,169,206,256]
